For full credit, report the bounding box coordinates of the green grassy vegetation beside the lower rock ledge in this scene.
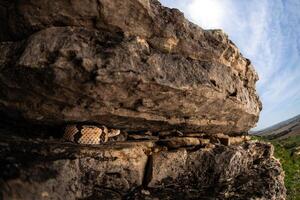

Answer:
[253,135,300,200]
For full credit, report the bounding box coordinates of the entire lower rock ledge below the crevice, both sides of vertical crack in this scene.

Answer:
[0,131,285,200]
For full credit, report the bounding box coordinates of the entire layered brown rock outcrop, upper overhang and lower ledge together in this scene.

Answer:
[0,0,285,200]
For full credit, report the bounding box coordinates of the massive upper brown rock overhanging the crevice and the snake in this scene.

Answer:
[0,0,261,134]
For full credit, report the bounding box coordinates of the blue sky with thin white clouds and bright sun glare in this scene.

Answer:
[161,0,300,129]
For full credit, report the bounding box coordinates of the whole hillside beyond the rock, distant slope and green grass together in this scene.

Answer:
[254,115,300,200]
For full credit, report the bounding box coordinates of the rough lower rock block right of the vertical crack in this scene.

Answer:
[148,142,285,200]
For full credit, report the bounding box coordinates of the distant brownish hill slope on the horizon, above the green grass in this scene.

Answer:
[253,115,300,139]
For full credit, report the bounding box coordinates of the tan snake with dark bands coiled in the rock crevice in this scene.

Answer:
[63,124,120,144]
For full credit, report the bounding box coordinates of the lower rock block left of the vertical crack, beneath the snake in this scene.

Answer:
[0,135,153,200]
